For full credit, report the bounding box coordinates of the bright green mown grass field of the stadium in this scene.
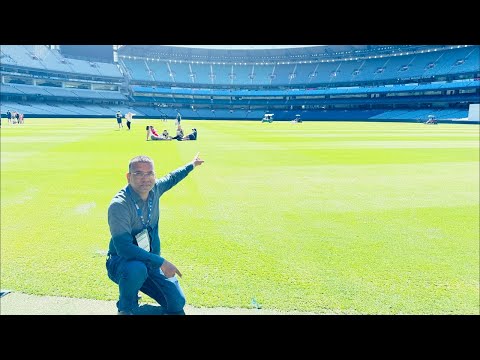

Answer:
[0,118,480,314]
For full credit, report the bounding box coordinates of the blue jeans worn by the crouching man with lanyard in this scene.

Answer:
[106,255,185,315]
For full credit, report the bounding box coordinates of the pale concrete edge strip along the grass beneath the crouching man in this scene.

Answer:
[0,292,322,315]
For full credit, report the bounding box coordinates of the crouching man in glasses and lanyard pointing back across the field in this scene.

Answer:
[105,153,204,315]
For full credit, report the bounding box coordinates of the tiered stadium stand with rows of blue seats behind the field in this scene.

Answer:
[0,45,480,123]
